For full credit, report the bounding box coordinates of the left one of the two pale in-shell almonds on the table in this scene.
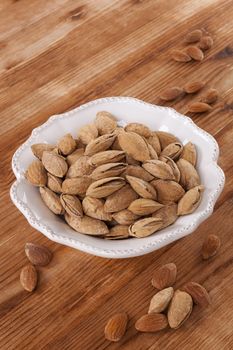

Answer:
[148,287,174,314]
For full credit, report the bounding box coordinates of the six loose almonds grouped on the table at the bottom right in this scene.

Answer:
[104,263,210,342]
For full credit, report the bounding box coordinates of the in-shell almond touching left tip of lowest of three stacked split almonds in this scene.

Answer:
[62,176,92,197]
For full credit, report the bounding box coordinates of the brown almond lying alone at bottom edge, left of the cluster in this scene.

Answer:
[104,312,128,342]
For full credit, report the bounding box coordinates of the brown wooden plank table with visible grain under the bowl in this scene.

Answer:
[0,0,233,350]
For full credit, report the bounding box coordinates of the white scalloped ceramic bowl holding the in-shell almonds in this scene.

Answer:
[10,97,225,258]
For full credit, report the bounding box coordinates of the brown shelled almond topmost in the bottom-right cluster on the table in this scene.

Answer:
[152,263,177,290]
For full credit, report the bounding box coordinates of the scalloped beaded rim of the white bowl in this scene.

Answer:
[10,97,225,258]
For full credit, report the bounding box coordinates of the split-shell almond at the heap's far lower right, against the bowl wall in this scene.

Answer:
[177,185,204,215]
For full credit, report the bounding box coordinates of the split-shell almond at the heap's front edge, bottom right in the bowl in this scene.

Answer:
[129,217,163,238]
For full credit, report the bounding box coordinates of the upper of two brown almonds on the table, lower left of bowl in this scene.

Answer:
[25,243,52,266]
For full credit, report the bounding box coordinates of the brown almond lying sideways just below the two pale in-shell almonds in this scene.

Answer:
[135,313,168,333]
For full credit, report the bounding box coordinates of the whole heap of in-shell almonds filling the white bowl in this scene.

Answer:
[25,111,204,239]
